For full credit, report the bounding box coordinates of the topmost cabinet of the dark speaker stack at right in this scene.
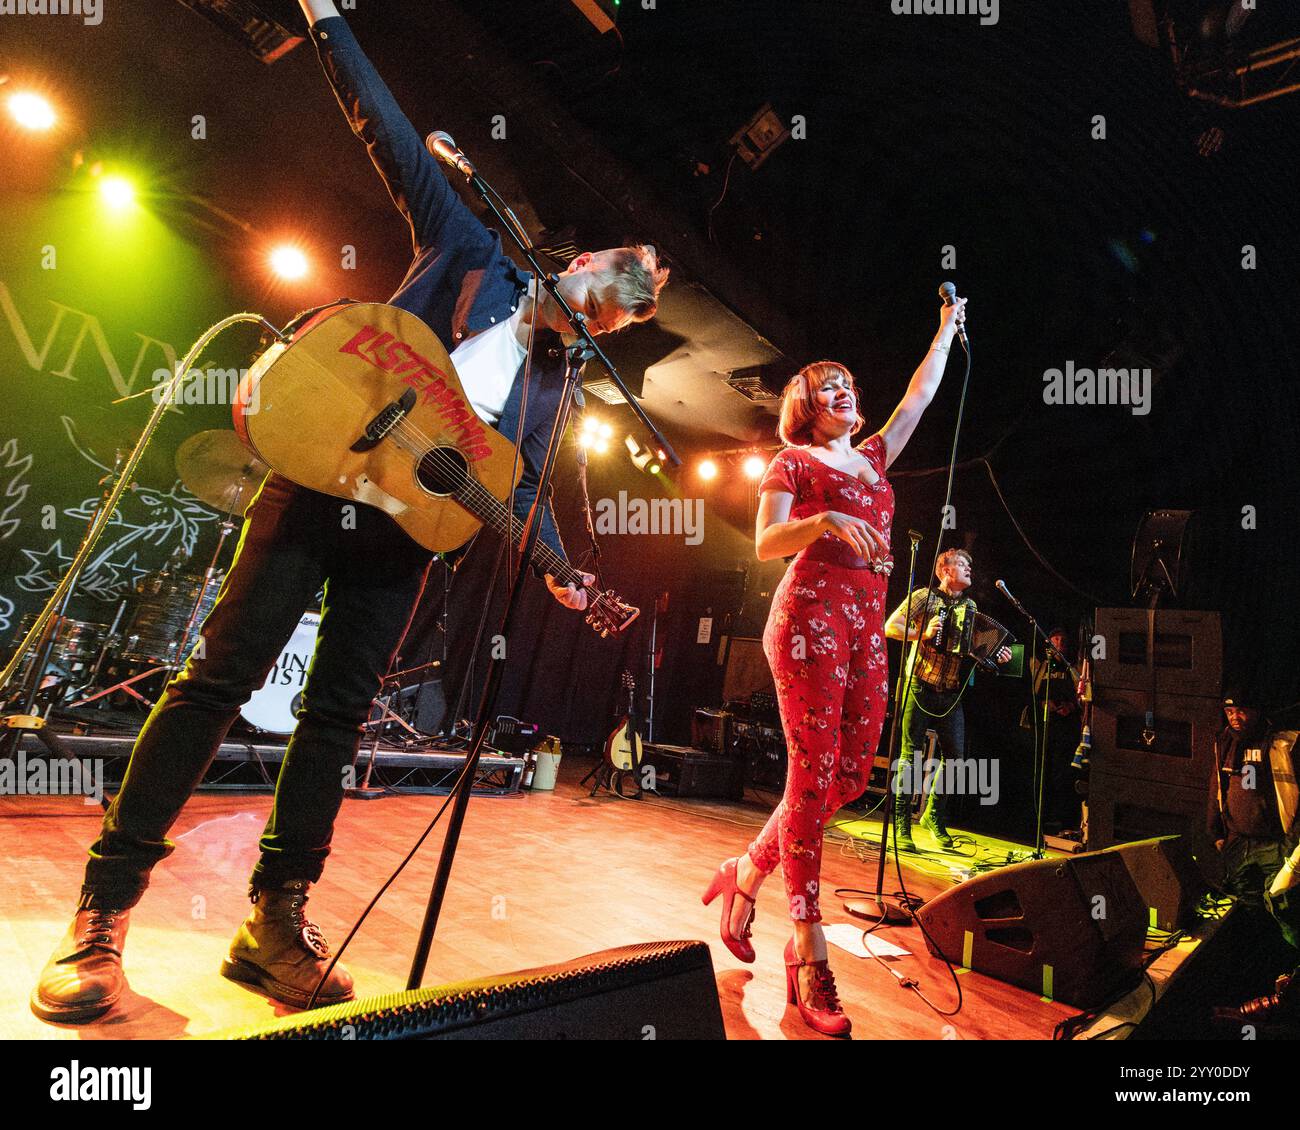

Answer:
[1093,609,1223,698]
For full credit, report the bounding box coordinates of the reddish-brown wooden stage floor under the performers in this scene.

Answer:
[0,759,1075,1040]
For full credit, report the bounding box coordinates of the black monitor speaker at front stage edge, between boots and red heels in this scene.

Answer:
[212,941,727,1040]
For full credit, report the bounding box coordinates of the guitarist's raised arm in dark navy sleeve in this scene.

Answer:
[298,0,475,251]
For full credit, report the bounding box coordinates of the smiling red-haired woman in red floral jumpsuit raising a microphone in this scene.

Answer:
[705,291,966,1035]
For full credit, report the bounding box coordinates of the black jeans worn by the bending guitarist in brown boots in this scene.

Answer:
[81,475,432,908]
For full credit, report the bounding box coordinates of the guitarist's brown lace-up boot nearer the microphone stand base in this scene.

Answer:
[221,879,352,1008]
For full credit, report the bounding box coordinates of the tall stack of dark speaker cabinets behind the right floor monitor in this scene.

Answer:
[1088,609,1223,873]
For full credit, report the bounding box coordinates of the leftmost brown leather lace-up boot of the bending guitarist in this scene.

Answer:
[31,909,131,1025]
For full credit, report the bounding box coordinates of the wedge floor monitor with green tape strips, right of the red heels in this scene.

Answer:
[917,852,1147,1008]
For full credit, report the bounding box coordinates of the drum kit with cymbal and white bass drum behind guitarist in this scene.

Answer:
[5,429,320,733]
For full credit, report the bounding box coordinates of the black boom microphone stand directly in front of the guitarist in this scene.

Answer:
[407,161,681,990]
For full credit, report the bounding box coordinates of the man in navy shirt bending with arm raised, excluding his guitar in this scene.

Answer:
[31,0,668,1022]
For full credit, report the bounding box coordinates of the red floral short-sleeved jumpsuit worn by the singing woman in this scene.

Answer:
[749,434,893,922]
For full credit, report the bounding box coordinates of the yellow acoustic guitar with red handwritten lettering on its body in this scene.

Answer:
[234,302,640,636]
